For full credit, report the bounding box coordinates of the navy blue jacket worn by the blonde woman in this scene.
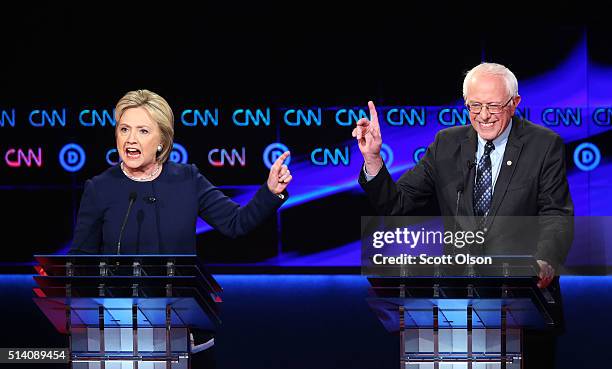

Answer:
[70,162,287,254]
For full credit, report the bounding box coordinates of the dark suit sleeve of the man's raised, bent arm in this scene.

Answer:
[359,133,440,215]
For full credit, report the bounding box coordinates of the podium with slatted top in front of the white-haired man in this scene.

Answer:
[368,264,558,369]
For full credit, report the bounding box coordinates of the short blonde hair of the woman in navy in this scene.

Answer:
[115,90,174,163]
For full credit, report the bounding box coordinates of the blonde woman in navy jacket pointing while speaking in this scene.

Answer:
[70,90,292,254]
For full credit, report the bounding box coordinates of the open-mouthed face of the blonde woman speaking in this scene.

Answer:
[115,107,161,172]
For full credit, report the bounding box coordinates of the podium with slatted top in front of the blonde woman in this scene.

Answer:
[34,255,222,369]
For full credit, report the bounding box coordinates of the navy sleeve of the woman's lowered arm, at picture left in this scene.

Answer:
[69,180,103,254]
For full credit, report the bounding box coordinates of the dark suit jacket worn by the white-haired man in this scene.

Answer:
[359,117,574,266]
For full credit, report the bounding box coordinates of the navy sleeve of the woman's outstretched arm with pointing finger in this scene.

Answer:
[192,165,287,237]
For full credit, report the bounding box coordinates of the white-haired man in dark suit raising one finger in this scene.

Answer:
[353,63,574,288]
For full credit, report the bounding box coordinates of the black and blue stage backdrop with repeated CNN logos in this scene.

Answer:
[0,5,612,266]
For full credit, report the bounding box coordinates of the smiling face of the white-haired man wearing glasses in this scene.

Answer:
[466,73,521,141]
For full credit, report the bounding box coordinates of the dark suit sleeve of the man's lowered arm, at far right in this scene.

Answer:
[535,135,574,266]
